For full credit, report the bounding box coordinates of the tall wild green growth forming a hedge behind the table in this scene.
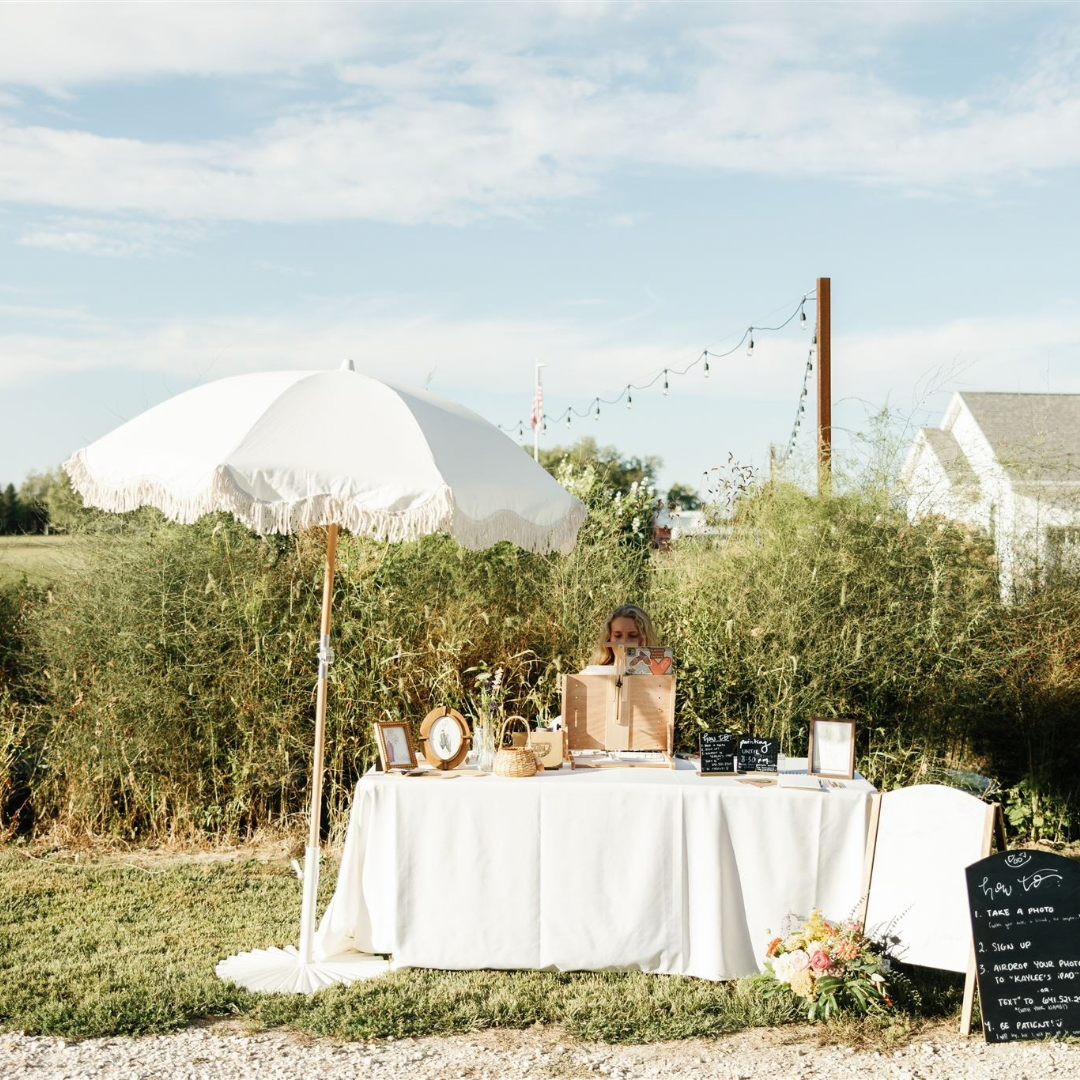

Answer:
[0,464,1080,839]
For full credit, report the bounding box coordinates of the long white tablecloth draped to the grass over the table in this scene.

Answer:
[316,760,874,978]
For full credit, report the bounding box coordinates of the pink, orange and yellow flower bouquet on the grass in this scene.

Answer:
[765,910,901,1020]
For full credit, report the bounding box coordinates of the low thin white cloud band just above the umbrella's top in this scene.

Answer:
[6,300,1080,420]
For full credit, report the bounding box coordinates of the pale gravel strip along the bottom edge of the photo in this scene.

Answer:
[0,1022,1080,1080]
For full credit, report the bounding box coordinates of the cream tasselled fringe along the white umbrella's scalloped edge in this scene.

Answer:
[64,450,586,553]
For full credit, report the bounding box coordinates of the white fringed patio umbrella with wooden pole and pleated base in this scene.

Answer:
[64,361,585,994]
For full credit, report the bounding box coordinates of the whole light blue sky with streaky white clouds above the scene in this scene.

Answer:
[0,3,1080,486]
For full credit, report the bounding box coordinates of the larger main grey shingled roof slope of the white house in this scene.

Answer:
[960,392,1080,482]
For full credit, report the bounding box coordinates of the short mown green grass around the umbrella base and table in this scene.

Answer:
[0,846,962,1042]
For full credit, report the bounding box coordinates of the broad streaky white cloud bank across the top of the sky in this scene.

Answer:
[0,4,1080,227]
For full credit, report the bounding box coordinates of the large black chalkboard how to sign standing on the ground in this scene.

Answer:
[967,851,1080,1042]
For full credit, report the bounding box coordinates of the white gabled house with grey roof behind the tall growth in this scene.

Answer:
[901,392,1080,596]
